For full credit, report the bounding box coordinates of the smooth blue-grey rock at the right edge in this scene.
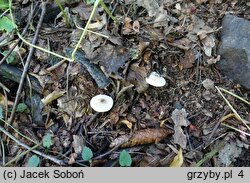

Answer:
[218,15,250,89]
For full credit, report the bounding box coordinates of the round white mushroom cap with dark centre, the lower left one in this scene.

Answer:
[90,94,114,112]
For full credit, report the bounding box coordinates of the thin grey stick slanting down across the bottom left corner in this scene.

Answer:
[0,126,65,165]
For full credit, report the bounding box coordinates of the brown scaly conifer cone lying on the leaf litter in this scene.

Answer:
[111,128,172,147]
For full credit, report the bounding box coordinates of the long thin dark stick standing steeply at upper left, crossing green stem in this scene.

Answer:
[9,2,47,124]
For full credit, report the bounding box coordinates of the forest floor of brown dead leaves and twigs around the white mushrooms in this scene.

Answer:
[0,0,250,166]
